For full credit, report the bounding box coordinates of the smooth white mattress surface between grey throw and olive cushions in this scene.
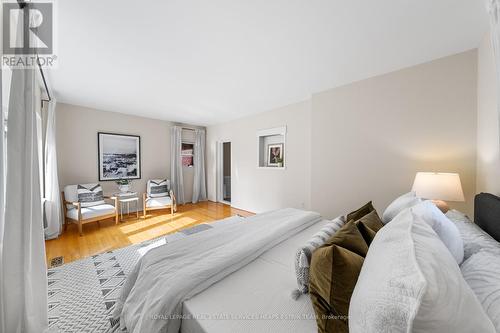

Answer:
[181,220,327,333]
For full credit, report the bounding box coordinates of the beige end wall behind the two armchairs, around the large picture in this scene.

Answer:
[56,103,172,202]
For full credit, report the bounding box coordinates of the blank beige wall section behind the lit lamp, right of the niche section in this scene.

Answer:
[311,50,476,217]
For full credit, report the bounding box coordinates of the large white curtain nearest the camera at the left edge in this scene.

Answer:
[0,69,48,333]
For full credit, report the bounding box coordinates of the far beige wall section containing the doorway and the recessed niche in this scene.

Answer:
[207,102,310,213]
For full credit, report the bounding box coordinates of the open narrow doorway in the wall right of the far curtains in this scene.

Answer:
[217,141,231,205]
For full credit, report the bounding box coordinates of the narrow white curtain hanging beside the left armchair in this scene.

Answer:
[44,99,62,239]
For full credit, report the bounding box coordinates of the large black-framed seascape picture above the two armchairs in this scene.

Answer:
[97,132,141,181]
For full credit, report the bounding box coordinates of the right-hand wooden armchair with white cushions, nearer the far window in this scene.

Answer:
[143,179,177,218]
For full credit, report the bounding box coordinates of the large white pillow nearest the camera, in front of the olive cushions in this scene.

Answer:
[349,209,495,333]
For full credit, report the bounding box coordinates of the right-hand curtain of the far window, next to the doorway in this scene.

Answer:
[193,129,207,203]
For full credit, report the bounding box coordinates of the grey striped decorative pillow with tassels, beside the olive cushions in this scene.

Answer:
[294,216,345,297]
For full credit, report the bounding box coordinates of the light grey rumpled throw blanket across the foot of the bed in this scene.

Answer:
[114,208,320,333]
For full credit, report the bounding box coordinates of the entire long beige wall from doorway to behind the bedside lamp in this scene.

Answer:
[207,50,477,217]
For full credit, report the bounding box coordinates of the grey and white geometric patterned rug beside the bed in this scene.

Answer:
[47,224,216,333]
